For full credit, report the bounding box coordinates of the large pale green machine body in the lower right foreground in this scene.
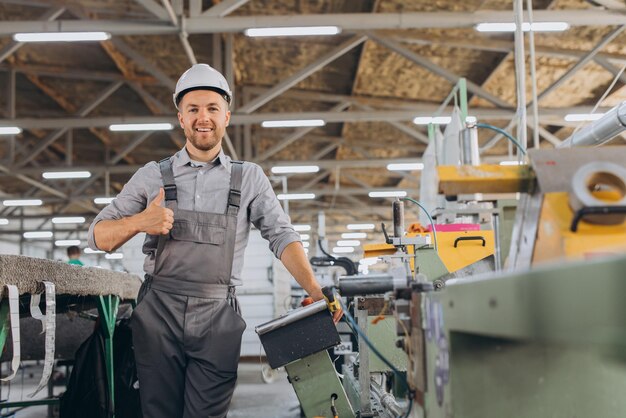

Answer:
[412,257,626,418]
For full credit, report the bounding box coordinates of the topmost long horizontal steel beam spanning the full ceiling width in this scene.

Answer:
[0,10,626,35]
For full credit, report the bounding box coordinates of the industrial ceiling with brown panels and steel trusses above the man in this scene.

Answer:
[0,0,626,247]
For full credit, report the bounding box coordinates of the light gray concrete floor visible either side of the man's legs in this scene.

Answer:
[2,362,300,418]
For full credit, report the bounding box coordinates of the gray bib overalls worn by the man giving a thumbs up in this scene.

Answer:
[131,158,246,418]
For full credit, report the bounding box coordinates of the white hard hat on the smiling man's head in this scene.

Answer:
[173,64,233,109]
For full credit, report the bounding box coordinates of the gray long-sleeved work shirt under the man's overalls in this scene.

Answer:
[88,148,300,286]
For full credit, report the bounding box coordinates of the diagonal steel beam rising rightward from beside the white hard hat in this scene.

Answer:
[237,35,367,113]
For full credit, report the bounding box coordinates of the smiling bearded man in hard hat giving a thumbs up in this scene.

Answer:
[89,64,341,418]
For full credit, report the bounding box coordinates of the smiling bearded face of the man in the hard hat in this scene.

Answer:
[178,90,230,152]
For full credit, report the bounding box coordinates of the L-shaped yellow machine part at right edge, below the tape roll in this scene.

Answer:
[533,192,626,264]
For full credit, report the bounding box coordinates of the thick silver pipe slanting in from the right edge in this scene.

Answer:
[557,101,626,148]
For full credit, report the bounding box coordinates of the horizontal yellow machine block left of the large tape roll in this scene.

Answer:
[437,164,534,196]
